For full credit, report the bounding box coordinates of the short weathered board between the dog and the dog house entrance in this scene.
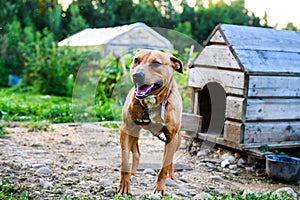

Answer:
[181,113,202,135]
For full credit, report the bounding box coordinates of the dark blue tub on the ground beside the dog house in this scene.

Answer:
[266,155,300,182]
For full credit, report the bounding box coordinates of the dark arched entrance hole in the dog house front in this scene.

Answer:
[198,82,226,135]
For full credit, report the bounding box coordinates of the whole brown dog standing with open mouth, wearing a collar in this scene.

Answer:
[118,50,182,195]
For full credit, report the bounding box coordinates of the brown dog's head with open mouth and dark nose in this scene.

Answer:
[130,50,182,99]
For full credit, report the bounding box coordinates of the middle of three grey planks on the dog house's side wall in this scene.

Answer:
[245,99,300,121]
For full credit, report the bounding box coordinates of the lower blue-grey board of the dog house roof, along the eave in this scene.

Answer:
[233,47,300,75]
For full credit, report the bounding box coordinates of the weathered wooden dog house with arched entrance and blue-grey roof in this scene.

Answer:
[188,24,300,149]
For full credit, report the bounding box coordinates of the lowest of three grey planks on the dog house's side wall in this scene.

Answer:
[244,121,300,144]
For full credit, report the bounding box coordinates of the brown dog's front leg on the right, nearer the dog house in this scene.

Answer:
[154,133,180,195]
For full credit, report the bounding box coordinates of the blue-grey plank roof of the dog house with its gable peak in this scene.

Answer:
[206,24,300,74]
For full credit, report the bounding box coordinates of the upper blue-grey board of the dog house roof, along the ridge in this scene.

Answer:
[220,24,300,53]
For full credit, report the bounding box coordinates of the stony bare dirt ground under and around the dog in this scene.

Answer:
[0,123,300,199]
